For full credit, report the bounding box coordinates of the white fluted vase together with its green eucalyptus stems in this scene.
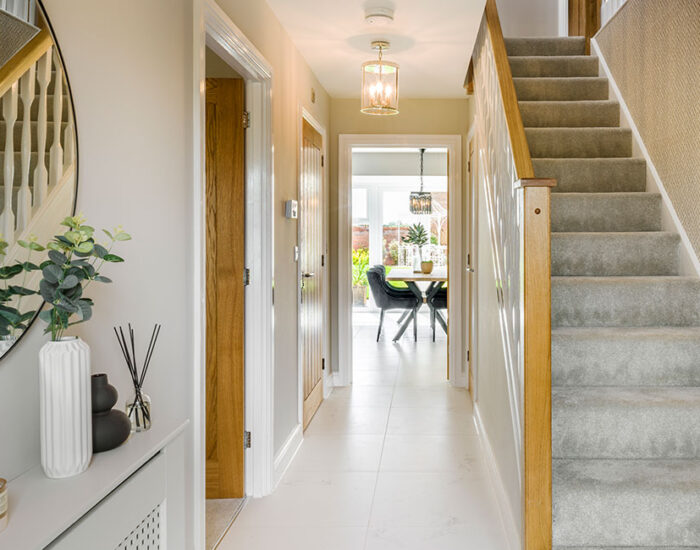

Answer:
[31,216,131,478]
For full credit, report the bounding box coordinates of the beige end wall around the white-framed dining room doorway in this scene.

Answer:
[329,97,474,371]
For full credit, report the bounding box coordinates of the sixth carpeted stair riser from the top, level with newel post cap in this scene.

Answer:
[532,158,646,193]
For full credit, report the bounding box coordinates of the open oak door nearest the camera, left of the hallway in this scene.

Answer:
[206,78,245,498]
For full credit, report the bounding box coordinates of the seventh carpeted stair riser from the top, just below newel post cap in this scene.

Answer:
[551,193,661,232]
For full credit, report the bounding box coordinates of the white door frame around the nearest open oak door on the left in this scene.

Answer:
[192,0,274,548]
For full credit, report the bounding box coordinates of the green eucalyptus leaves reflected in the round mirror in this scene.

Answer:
[0,237,39,336]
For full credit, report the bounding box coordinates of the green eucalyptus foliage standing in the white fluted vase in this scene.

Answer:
[28,216,131,341]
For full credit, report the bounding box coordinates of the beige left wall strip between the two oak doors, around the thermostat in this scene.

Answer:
[217,0,330,452]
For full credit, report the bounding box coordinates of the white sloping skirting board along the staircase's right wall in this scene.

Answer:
[591,36,700,276]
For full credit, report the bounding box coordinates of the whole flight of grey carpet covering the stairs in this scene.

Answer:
[506,38,700,550]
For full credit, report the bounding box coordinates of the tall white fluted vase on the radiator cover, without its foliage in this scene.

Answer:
[39,338,92,478]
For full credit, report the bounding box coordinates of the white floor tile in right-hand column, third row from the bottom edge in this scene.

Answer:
[380,434,483,475]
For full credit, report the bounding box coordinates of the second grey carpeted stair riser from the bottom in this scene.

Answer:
[552,388,700,459]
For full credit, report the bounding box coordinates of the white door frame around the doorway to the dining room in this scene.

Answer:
[333,134,466,387]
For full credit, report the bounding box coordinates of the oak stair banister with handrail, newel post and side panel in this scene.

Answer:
[465,0,556,550]
